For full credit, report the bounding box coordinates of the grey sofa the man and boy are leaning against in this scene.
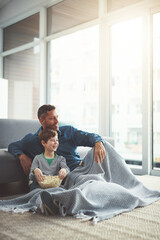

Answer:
[0,119,114,195]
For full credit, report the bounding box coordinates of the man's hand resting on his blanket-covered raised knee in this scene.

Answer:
[94,142,106,164]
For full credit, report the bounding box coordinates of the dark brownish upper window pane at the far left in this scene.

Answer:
[3,13,39,51]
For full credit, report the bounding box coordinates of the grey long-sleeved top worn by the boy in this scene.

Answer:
[29,154,70,180]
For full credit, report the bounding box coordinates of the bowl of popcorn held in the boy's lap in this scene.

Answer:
[38,176,62,189]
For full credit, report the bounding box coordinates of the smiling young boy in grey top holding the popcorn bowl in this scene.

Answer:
[29,129,70,191]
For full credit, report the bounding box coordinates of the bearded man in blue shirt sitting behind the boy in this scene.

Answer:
[8,104,106,175]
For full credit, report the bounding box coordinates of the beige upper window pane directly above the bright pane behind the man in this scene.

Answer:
[48,0,98,34]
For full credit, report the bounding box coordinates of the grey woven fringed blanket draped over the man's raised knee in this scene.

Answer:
[0,143,160,223]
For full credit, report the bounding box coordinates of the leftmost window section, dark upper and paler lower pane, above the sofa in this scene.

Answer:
[0,13,40,119]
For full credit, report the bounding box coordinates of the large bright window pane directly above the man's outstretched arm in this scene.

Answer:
[49,26,99,132]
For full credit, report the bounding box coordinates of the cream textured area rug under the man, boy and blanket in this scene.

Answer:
[0,175,160,240]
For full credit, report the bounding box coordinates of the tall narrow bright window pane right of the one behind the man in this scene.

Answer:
[111,18,142,165]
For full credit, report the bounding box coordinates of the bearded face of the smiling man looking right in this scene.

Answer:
[40,110,59,131]
